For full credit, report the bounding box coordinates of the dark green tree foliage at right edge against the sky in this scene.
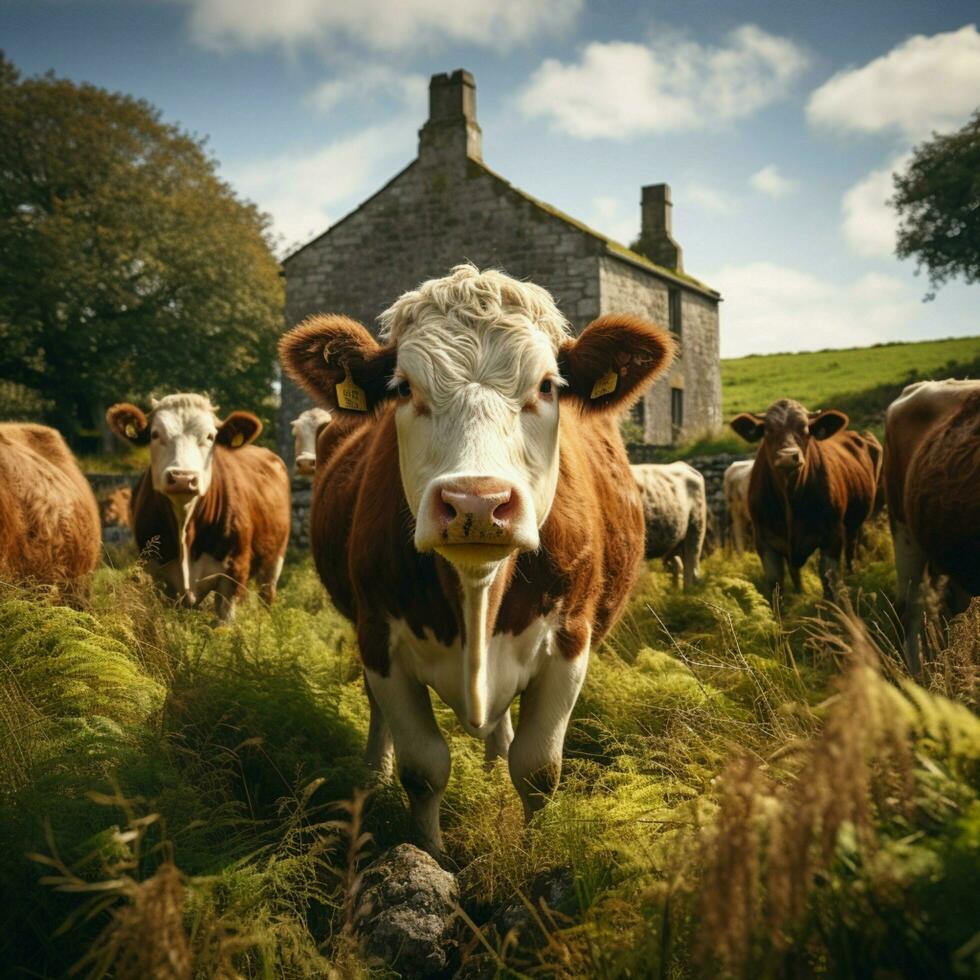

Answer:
[892,109,980,299]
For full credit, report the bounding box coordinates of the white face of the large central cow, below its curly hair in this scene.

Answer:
[392,315,561,567]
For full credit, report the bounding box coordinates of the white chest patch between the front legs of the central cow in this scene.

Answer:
[389,613,560,738]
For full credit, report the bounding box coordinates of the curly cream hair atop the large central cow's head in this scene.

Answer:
[379,263,571,353]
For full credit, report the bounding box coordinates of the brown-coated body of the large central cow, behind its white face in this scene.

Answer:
[311,407,643,673]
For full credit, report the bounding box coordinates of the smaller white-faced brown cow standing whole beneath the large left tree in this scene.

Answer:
[106,394,291,620]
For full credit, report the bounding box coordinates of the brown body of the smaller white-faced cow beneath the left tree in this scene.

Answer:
[132,446,290,603]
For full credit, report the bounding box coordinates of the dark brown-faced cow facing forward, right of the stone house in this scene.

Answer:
[730,398,881,604]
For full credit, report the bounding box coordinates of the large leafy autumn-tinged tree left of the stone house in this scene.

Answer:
[0,54,283,446]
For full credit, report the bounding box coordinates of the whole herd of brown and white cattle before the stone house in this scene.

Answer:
[0,265,980,853]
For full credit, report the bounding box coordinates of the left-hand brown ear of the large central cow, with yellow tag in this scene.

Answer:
[279,315,396,412]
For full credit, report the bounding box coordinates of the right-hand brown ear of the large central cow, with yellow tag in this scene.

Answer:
[558,313,675,412]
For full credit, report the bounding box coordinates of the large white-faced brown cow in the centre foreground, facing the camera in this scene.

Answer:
[279,265,674,855]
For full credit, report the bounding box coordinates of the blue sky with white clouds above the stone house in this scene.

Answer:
[0,0,980,356]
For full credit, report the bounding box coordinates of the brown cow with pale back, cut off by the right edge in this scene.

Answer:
[884,380,980,674]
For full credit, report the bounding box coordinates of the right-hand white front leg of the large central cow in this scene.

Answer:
[507,627,591,820]
